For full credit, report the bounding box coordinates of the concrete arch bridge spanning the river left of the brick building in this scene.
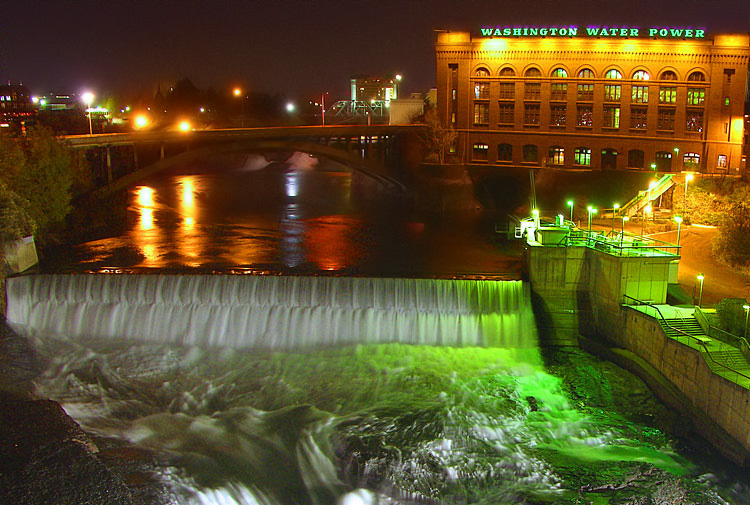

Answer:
[65,125,419,197]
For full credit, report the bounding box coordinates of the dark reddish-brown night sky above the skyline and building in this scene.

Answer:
[0,0,750,99]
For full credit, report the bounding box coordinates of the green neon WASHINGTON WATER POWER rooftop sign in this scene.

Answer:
[480,25,706,39]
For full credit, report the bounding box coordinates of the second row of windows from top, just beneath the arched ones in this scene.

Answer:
[474,82,706,106]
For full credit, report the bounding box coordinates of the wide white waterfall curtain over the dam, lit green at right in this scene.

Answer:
[6,274,537,349]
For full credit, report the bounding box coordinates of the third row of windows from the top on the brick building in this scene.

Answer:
[474,101,703,133]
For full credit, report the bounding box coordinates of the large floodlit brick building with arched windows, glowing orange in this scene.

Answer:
[436,26,750,174]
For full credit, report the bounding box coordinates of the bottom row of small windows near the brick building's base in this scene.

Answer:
[472,142,712,171]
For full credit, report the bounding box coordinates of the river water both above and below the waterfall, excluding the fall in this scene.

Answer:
[23,156,750,505]
